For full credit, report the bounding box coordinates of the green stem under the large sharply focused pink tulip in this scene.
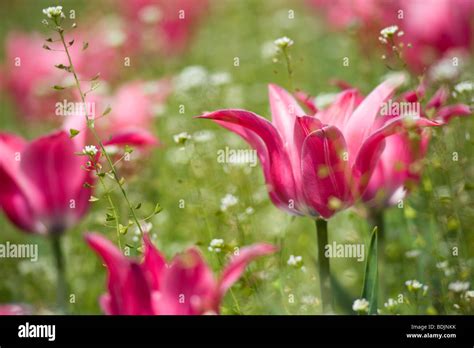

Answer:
[316,219,331,313]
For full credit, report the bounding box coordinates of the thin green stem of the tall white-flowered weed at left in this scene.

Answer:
[59,31,143,236]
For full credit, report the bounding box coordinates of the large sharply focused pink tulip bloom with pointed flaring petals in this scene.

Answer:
[199,76,435,218]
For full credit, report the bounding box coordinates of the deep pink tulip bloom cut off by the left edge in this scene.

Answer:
[0,121,93,234]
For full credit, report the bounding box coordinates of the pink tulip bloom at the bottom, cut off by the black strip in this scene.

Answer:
[86,234,276,315]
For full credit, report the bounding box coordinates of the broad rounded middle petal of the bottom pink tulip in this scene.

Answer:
[155,248,218,315]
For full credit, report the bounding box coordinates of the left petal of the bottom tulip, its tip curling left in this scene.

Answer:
[85,234,154,315]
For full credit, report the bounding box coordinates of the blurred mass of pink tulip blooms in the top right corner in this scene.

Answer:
[308,0,474,72]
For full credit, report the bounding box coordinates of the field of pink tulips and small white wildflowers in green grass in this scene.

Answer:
[0,0,474,315]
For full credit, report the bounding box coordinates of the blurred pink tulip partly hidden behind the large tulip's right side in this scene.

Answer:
[363,87,472,210]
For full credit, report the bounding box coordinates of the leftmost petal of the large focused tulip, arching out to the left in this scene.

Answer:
[199,109,299,214]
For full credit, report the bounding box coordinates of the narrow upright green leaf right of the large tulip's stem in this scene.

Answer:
[361,226,378,314]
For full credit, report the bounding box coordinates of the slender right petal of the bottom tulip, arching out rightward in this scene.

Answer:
[218,243,278,297]
